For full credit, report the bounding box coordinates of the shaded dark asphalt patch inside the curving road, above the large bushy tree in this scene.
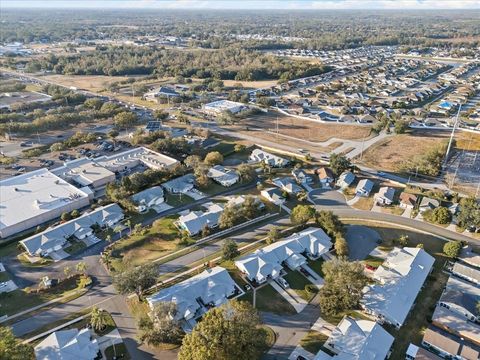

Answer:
[345,225,381,260]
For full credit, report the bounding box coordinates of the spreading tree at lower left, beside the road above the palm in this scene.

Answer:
[113,264,158,297]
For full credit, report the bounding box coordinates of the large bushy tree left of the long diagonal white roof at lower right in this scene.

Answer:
[319,258,367,315]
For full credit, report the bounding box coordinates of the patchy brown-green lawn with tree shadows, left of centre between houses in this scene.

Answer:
[112,216,180,271]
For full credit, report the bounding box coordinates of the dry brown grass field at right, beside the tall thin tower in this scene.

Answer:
[361,134,447,171]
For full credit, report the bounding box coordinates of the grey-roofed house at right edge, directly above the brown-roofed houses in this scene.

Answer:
[438,276,480,322]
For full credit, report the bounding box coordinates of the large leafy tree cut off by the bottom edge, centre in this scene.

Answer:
[178,300,267,360]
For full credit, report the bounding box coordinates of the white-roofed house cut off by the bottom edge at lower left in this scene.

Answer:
[34,328,100,360]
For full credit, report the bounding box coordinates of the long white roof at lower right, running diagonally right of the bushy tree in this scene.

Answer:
[361,247,435,326]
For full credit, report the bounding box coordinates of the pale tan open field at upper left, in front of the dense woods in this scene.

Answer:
[42,75,135,92]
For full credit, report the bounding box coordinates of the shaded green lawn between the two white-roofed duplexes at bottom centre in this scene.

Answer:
[238,285,297,315]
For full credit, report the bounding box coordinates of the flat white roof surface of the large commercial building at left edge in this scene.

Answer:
[0,169,88,235]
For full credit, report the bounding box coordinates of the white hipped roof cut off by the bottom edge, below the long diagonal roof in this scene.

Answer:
[327,317,394,360]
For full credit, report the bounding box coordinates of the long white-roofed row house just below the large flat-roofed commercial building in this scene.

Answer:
[20,204,124,256]
